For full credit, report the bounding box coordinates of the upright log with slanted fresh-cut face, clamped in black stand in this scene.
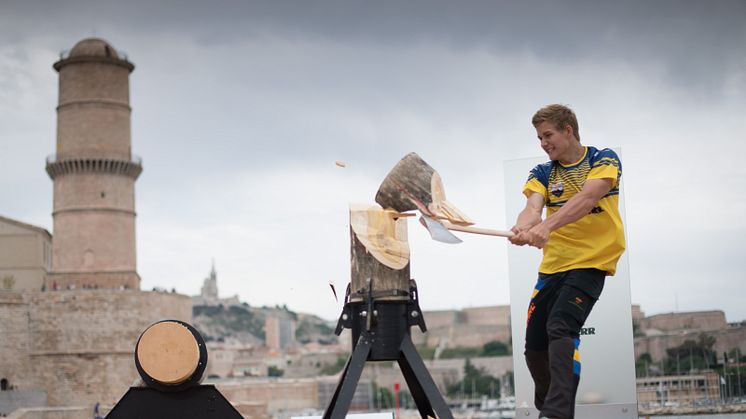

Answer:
[350,205,410,302]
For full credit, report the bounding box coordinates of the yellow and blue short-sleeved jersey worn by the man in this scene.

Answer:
[523,146,625,275]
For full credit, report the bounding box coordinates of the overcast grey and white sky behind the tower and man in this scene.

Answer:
[0,0,746,321]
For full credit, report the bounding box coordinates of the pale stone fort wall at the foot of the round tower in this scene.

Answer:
[0,290,192,406]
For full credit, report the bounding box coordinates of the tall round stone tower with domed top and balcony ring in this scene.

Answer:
[46,38,142,289]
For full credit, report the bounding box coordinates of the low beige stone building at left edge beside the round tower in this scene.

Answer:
[0,216,52,292]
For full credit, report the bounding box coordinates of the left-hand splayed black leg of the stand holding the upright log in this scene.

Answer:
[323,333,371,419]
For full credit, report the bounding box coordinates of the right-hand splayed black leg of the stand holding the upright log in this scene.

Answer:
[399,336,453,419]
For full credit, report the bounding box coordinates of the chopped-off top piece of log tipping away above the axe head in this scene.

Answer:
[376,153,474,225]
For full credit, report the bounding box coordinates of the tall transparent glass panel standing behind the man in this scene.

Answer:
[504,149,637,418]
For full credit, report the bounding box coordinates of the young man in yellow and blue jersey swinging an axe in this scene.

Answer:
[510,105,625,419]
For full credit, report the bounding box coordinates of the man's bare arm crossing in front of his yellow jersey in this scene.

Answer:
[516,178,614,249]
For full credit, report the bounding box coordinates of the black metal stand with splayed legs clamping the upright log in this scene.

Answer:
[323,280,453,419]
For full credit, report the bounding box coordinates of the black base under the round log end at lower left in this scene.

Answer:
[106,385,243,419]
